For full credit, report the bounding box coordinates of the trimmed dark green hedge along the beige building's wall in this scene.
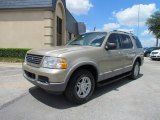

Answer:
[0,48,30,59]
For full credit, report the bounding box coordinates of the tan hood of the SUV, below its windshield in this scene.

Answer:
[28,46,92,57]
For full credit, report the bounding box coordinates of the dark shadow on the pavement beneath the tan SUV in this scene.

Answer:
[29,74,143,109]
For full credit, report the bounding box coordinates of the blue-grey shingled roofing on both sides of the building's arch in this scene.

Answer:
[0,0,85,35]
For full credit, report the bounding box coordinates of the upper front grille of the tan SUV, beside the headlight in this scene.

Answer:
[26,54,43,65]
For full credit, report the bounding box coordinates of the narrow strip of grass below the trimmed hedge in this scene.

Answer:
[0,57,24,63]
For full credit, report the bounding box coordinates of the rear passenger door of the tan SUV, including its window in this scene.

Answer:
[119,34,136,71]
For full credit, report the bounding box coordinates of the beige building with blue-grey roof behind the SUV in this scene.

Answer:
[0,0,86,48]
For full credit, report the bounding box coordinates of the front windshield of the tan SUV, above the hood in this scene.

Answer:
[67,32,107,47]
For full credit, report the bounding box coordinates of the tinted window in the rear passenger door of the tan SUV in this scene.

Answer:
[120,34,133,49]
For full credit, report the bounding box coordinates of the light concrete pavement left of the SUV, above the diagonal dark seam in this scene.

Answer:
[0,63,33,109]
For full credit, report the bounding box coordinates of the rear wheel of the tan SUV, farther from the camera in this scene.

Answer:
[130,61,140,80]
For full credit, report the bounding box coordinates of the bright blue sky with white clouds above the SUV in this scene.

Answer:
[66,0,160,47]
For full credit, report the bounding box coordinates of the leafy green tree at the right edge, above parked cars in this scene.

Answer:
[146,11,160,46]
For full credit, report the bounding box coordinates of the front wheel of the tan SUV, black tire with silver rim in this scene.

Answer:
[65,70,95,104]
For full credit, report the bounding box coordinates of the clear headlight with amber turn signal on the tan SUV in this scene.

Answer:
[42,57,68,69]
